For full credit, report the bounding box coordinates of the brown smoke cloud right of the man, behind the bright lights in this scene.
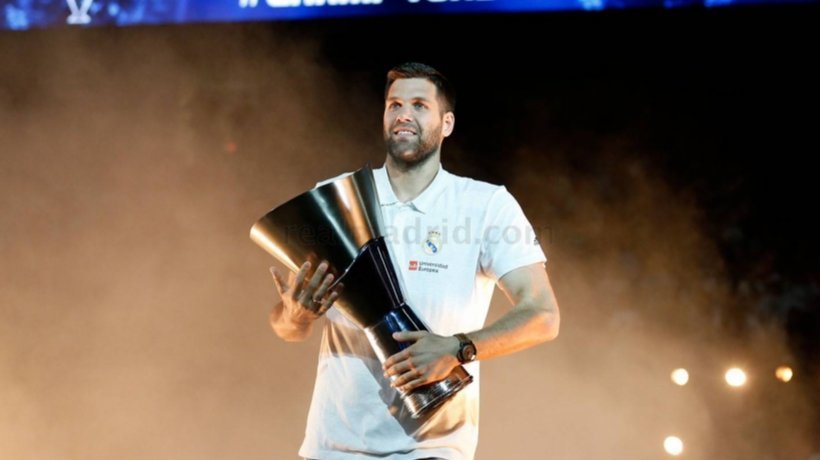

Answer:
[468,135,814,459]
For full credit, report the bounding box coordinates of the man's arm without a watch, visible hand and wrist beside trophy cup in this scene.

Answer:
[270,262,341,342]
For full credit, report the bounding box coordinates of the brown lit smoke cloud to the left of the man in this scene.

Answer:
[0,27,380,459]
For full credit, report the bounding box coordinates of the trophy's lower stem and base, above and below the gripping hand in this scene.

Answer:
[364,305,473,418]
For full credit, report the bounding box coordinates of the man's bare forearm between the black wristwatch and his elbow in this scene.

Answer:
[467,301,560,360]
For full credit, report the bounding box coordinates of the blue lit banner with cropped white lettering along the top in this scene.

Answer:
[0,0,820,30]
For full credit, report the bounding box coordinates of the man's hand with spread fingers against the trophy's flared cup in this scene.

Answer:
[270,261,343,325]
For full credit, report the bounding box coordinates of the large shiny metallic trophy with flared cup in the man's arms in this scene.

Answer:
[250,166,473,418]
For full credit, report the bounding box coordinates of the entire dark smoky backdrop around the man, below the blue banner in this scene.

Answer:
[0,5,820,460]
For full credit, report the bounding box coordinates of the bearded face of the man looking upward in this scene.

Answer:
[384,78,454,168]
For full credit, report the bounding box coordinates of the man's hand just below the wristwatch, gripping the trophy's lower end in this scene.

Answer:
[383,331,460,393]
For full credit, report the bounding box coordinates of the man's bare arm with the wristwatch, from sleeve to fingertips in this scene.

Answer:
[384,263,560,391]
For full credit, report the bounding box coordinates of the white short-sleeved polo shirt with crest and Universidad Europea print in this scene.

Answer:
[299,167,546,460]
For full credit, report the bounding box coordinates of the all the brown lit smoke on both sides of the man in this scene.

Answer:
[0,19,811,460]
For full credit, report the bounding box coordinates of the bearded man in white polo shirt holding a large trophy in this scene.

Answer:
[271,63,559,460]
